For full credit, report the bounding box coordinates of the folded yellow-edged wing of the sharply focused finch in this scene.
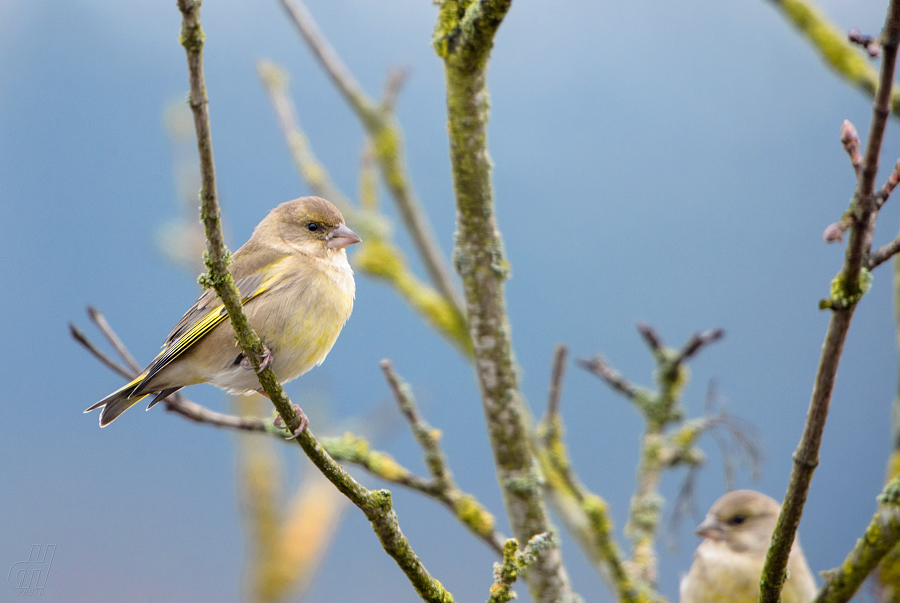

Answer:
[131,273,279,396]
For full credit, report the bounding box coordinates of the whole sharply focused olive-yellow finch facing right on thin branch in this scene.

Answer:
[84,197,360,427]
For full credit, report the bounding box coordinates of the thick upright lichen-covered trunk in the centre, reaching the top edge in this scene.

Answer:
[434,0,575,603]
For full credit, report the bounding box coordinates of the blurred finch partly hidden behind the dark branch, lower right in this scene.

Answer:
[680,490,816,603]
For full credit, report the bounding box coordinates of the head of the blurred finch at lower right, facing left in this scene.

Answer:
[695,490,781,554]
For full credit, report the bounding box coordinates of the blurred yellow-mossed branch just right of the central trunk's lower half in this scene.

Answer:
[535,345,659,603]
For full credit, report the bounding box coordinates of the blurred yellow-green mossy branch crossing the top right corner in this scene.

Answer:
[769,0,900,116]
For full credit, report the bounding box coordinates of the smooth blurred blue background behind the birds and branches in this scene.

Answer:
[0,0,900,602]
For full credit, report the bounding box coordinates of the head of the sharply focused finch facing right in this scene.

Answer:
[268,197,362,257]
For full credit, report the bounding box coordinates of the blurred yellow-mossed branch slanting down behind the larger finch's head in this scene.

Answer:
[258,61,472,357]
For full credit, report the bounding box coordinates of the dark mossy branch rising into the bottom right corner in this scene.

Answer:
[814,476,900,603]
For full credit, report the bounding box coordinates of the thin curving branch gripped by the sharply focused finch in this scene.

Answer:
[178,0,453,603]
